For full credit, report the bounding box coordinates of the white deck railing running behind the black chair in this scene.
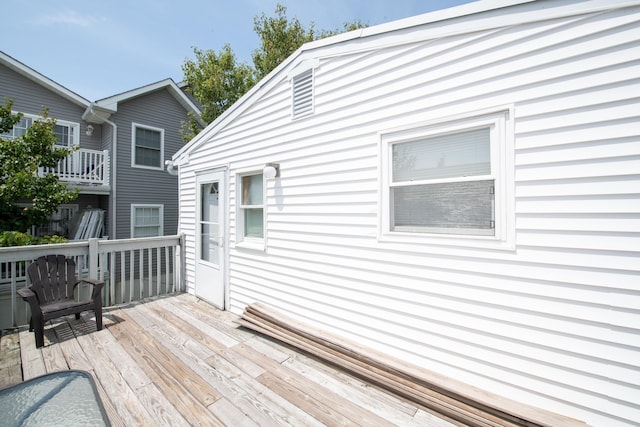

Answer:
[0,235,185,330]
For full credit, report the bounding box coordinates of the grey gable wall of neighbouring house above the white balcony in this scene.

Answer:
[0,65,100,150]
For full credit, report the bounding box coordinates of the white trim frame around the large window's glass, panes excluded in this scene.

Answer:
[378,106,515,250]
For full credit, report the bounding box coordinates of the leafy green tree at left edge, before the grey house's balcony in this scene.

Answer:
[0,100,78,231]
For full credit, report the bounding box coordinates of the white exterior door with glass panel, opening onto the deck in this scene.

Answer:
[195,171,226,309]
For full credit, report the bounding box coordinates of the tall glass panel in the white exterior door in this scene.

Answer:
[200,182,221,265]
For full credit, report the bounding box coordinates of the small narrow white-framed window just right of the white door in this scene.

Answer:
[238,173,264,243]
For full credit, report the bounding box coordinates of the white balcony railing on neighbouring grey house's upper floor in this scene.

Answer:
[41,148,109,186]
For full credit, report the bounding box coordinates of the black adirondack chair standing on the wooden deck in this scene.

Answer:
[18,255,104,347]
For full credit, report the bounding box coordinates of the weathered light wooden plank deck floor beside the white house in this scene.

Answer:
[0,294,452,427]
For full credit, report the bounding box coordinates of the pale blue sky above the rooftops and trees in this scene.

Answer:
[5,0,470,101]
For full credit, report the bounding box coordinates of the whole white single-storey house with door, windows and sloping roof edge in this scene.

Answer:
[173,0,640,427]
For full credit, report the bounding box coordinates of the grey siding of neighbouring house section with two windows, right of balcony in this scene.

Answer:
[114,89,187,239]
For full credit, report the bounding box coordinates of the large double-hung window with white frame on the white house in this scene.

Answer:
[381,112,510,244]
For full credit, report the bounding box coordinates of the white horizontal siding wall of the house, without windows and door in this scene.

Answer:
[180,2,640,426]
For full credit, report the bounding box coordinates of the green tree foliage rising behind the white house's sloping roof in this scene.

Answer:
[182,4,367,140]
